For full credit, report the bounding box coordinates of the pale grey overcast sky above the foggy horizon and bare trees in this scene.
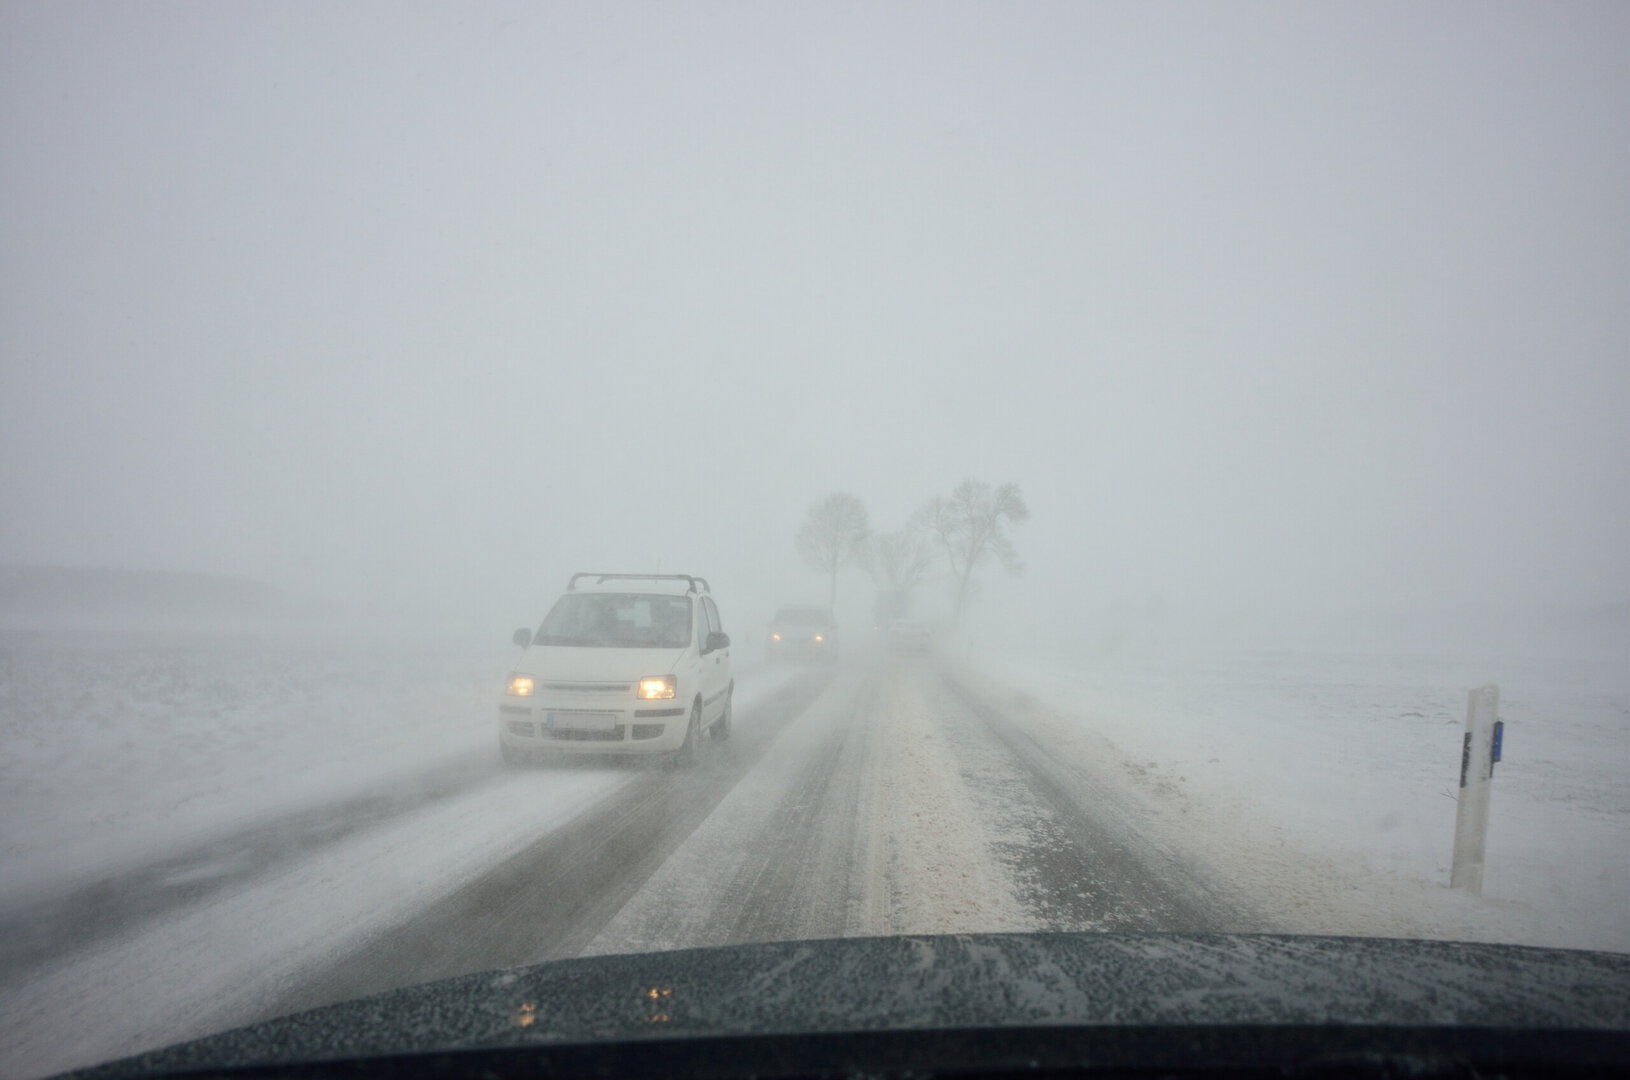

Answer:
[0,0,1630,632]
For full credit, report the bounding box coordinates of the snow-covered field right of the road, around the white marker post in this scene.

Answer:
[975,650,1630,951]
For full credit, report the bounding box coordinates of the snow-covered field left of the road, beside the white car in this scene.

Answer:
[0,630,515,902]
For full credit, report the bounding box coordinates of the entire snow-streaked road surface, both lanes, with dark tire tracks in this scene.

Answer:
[0,658,1253,1075]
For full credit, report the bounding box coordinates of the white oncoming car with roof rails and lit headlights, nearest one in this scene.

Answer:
[499,573,735,764]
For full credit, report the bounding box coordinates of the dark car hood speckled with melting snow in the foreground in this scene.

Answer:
[80,933,1630,1077]
